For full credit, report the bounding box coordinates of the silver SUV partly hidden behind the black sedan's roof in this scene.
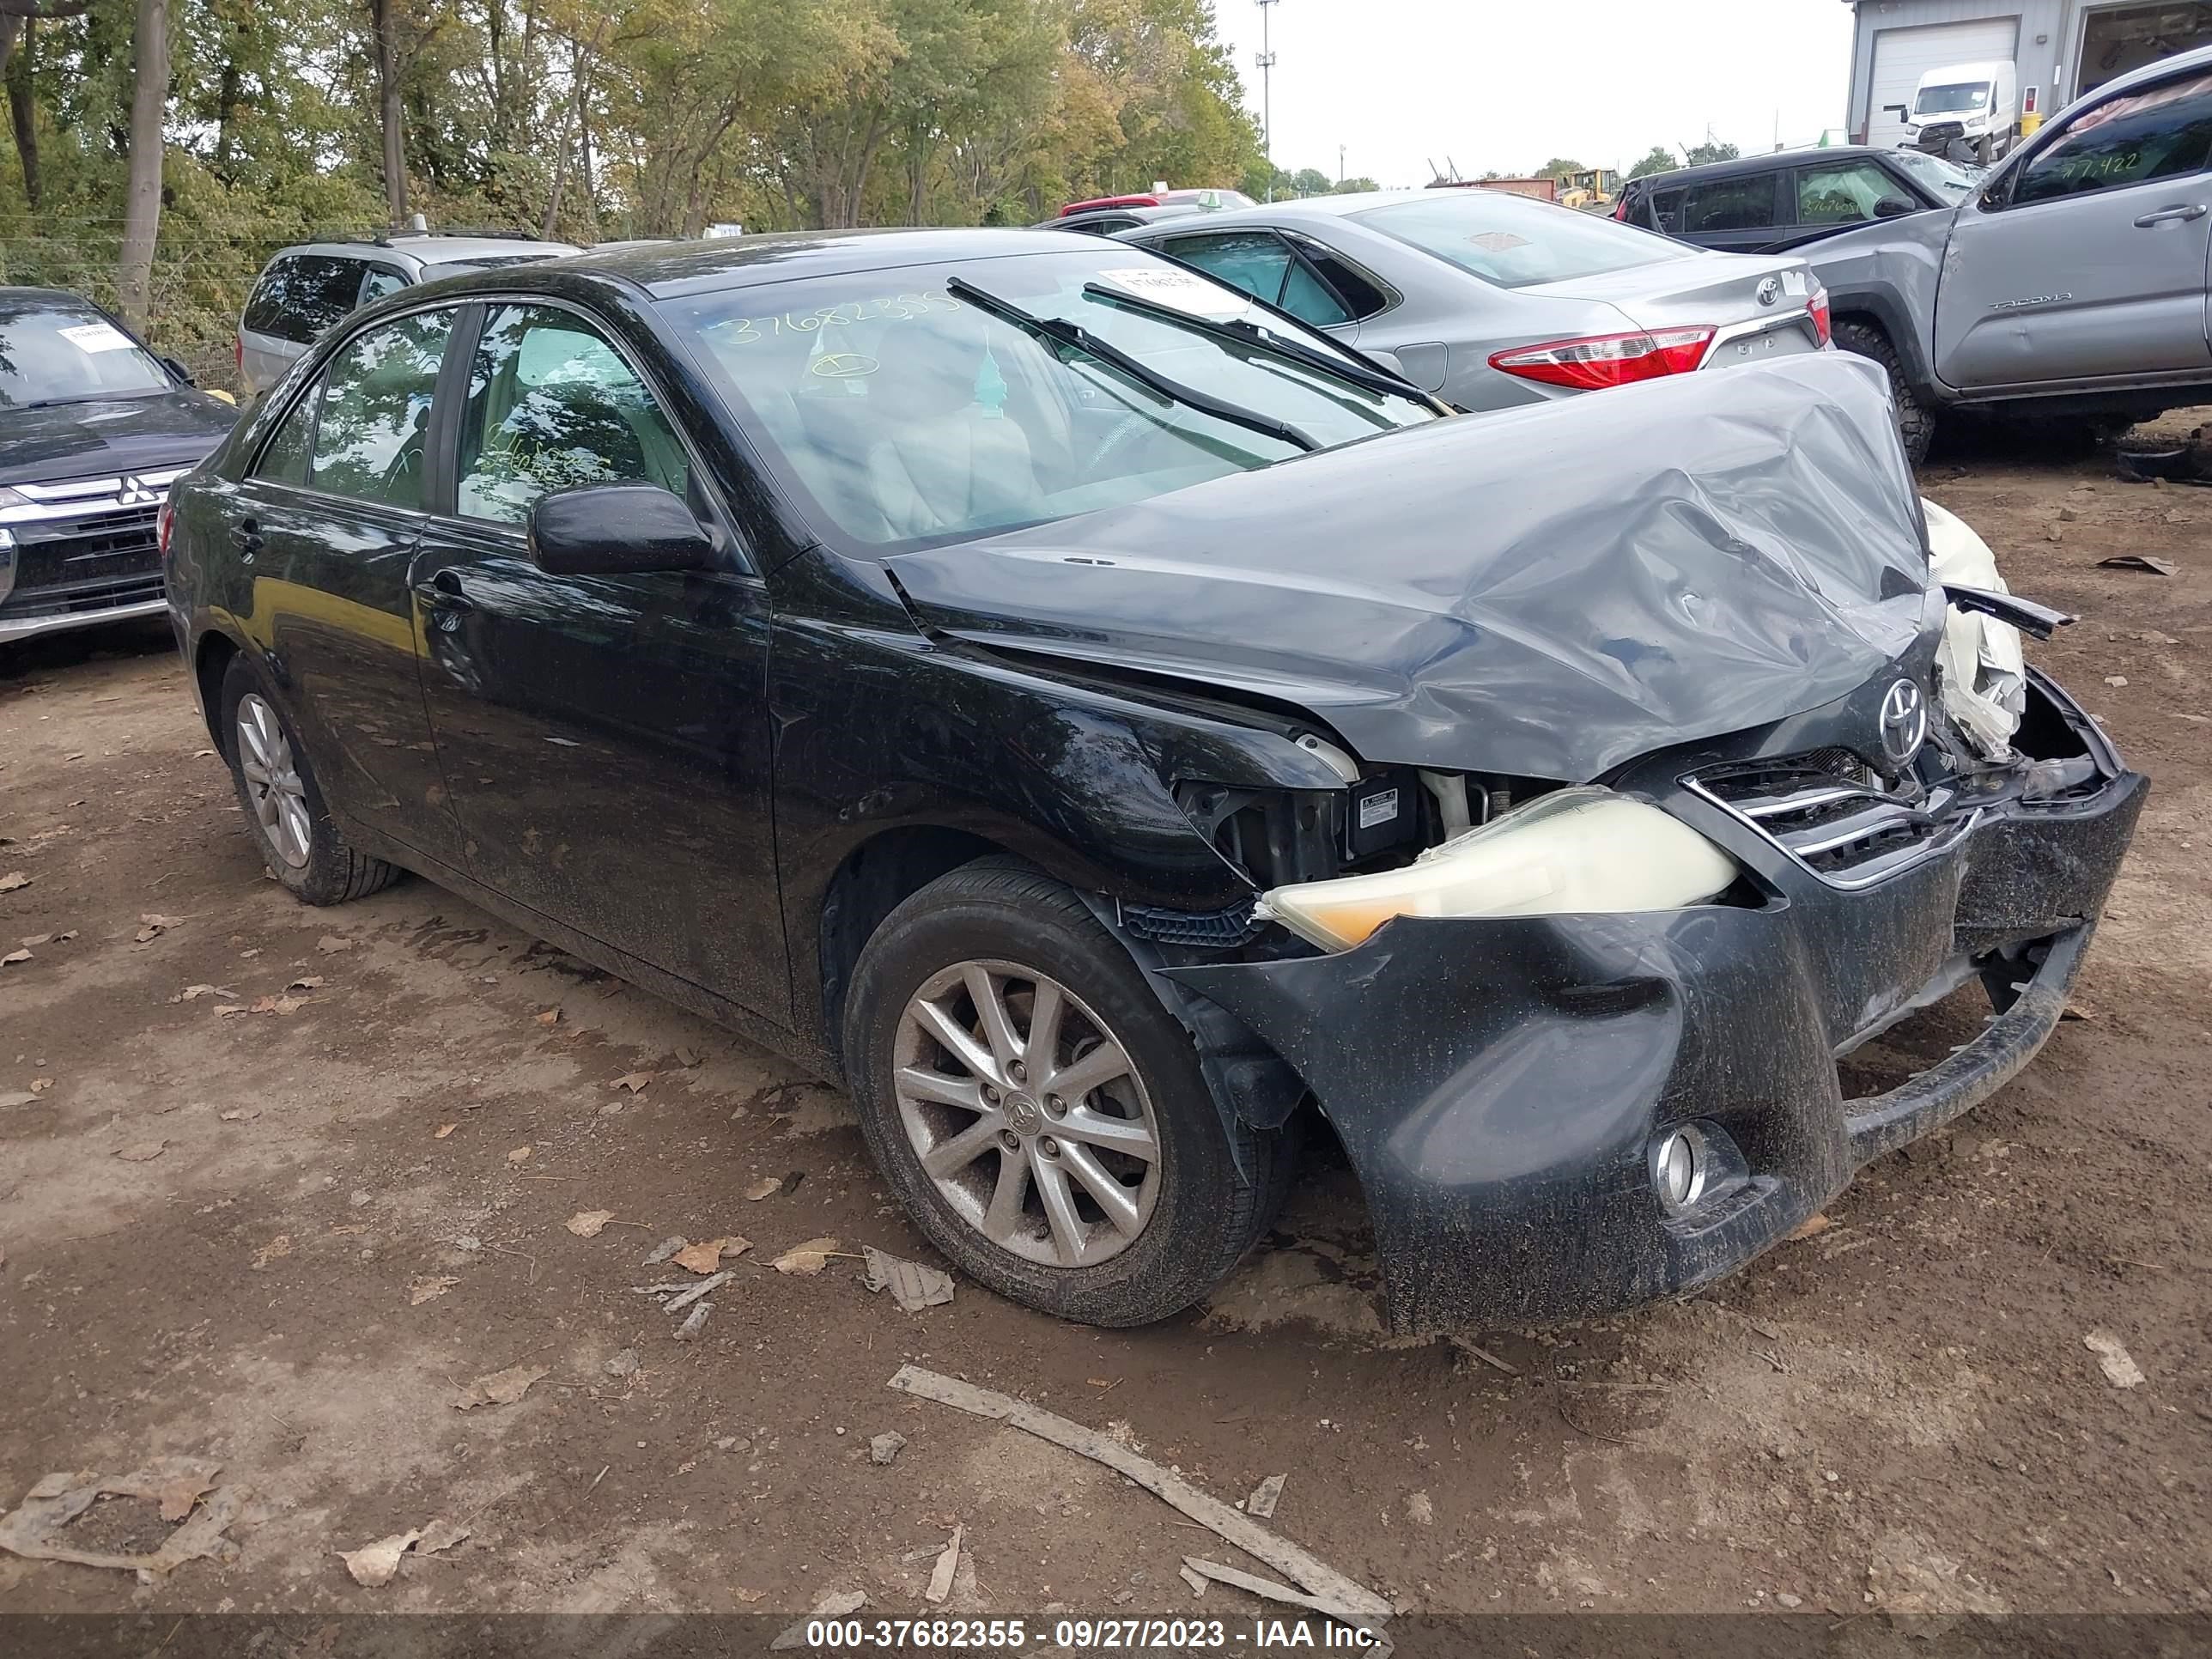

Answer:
[239,228,581,398]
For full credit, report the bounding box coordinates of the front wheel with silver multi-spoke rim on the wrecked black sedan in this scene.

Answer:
[845,863,1285,1325]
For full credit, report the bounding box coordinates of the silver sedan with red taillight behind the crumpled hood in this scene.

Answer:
[1121,188,1829,410]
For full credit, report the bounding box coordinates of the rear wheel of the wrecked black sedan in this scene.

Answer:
[219,653,400,905]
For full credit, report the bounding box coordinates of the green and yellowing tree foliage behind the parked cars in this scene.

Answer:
[0,0,1265,385]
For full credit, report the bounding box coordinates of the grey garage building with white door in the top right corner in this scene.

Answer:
[1844,0,2212,143]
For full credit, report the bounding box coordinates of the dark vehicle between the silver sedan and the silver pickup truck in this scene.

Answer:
[1613,143,1978,254]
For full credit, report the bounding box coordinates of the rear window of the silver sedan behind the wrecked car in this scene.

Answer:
[1354,191,1698,288]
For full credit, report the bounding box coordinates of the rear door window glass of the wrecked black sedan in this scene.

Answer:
[302,312,453,508]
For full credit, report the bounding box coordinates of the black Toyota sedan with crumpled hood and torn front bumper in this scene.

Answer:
[166,232,2146,1329]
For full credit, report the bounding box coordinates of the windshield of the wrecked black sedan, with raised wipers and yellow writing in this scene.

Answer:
[664,239,1436,553]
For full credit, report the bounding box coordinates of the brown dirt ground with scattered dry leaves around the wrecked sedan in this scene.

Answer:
[0,422,2212,1617]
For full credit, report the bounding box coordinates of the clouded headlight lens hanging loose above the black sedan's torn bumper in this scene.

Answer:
[1261,787,1736,951]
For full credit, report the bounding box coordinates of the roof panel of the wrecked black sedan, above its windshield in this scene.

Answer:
[528,226,1115,299]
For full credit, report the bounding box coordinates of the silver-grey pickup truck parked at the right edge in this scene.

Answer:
[1725,49,2212,460]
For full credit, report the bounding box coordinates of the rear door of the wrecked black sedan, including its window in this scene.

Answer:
[230,307,460,863]
